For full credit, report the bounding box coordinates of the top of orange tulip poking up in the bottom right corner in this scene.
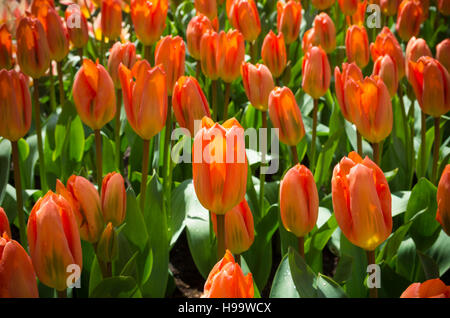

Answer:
[400,278,450,298]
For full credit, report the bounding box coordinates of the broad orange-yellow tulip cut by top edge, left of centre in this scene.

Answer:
[130,0,169,46]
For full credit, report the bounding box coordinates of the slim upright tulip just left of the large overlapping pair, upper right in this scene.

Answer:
[302,46,331,99]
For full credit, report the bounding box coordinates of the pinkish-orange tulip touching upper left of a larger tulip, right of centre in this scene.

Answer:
[241,63,275,112]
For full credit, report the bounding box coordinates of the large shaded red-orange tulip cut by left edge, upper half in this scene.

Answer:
[0,69,32,141]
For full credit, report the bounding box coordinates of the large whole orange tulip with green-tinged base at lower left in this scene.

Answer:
[27,191,83,291]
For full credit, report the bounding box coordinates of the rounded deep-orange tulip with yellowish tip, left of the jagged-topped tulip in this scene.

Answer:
[72,59,116,130]
